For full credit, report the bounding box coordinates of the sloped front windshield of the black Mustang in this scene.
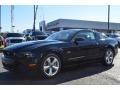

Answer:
[46,30,75,41]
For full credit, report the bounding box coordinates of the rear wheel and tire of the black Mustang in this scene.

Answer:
[102,48,114,66]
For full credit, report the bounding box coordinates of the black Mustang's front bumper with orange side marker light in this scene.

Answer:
[2,56,38,71]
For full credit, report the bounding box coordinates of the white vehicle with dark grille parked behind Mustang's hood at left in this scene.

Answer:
[5,33,25,46]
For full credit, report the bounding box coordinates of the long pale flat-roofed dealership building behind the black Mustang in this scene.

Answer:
[47,19,120,33]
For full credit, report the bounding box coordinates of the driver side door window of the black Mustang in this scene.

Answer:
[74,31,95,41]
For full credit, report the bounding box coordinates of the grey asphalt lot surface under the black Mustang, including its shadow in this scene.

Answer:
[0,49,120,85]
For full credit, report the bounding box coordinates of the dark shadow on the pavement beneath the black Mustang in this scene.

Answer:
[0,63,114,85]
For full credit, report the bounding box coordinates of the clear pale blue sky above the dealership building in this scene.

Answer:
[1,5,120,32]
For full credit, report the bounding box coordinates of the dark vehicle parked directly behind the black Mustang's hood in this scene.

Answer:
[28,31,47,40]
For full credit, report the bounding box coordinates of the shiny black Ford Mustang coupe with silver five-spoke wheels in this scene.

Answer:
[2,30,118,78]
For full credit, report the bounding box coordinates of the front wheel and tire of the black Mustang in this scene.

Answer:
[39,54,61,78]
